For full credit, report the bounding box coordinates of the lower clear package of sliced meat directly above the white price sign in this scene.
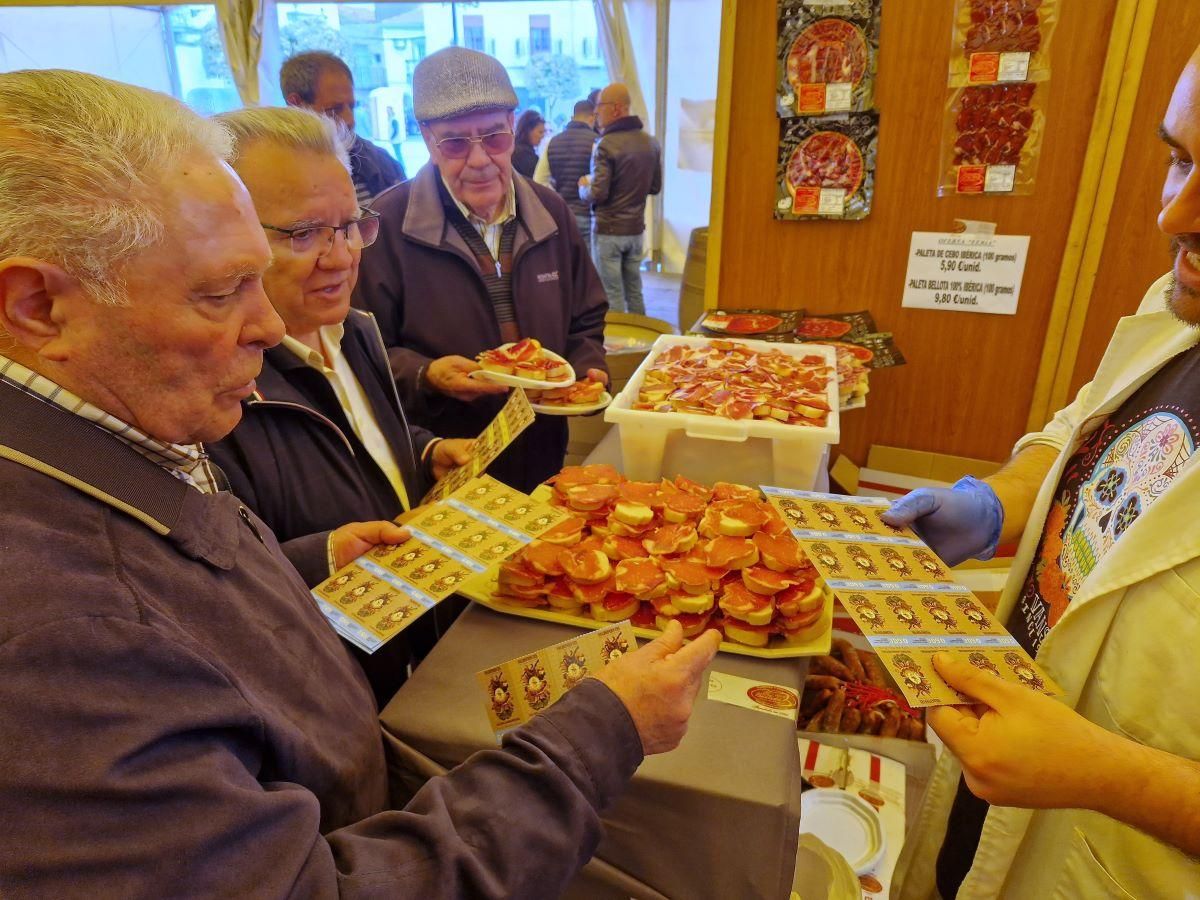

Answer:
[937,83,1049,197]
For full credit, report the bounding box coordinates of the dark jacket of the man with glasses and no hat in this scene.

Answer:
[209,310,444,709]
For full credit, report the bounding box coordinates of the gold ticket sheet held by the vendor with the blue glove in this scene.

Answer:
[762,486,1061,707]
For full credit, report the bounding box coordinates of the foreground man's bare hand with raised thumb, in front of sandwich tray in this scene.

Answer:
[595,622,721,756]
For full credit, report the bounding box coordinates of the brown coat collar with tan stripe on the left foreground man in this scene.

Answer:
[0,383,241,570]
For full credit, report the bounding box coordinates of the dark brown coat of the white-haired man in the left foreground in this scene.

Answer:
[0,383,642,900]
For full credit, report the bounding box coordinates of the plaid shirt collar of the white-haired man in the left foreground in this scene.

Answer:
[0,356,221,493]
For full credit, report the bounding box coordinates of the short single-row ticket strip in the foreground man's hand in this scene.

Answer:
[475,619,637,737]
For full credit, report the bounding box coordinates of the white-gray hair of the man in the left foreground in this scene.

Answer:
[0,70,233,305]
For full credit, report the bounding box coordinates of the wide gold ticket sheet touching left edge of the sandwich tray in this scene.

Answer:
[312,475,565,653]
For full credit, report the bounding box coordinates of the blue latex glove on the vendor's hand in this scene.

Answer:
[883,475,1004,565]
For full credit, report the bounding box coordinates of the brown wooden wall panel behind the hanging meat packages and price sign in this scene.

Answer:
[716,0,1116,462]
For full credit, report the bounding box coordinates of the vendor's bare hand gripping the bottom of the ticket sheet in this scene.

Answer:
[928,653,1121,809]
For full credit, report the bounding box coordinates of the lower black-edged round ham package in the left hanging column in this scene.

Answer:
[775,113,880,220]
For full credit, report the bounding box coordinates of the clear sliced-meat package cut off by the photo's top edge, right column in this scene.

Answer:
[949,0,1061,88]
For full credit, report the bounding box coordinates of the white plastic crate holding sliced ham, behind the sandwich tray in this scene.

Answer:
[605,335,841,490]
